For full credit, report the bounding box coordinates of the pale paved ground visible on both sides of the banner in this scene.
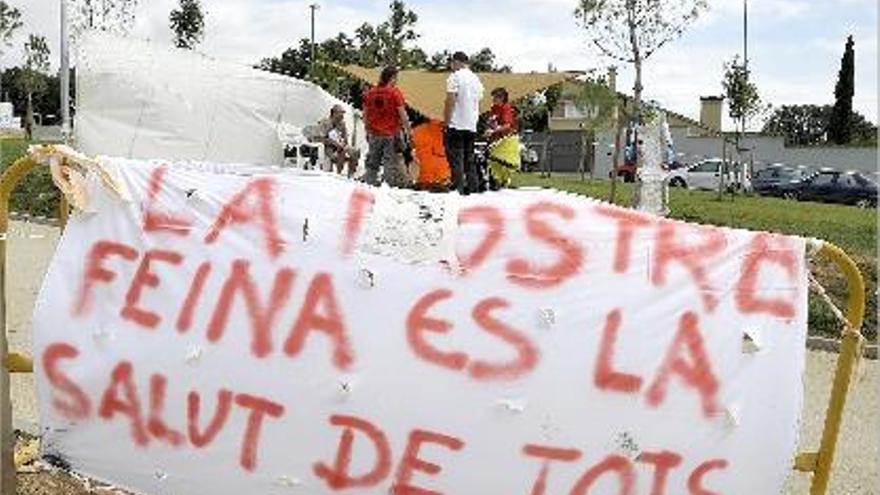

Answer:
[8,222,880,495]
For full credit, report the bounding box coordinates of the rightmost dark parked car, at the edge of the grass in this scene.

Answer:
[798,169,877,208]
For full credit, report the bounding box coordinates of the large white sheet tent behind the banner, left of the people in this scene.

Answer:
[74,33,366,165]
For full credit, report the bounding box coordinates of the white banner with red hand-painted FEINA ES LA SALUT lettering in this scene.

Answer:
[34,159,807,495]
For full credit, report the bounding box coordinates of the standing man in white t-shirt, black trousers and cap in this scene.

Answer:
[443,52,483,194]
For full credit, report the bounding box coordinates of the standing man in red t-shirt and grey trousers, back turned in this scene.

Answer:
[364,67,412,185]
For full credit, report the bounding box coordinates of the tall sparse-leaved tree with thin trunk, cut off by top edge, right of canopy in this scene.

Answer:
[575,0,707,128]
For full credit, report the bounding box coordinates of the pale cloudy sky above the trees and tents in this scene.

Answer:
[6,0,878,132]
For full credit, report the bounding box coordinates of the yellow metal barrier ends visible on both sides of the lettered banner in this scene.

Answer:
[0,153,865,495]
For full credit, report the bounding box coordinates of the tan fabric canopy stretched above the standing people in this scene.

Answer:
[340,65,570,120]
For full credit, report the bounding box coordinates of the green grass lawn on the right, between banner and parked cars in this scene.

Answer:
[514,174,877,340]
